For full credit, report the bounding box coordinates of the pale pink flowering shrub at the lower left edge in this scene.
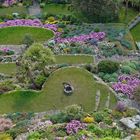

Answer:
[0,118,13,132]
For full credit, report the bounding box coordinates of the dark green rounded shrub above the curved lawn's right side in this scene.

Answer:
[98,60,119,74]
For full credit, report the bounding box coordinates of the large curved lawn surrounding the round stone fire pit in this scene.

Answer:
[0,67,116,113]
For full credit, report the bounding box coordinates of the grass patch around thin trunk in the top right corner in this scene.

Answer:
[118,7,139,24]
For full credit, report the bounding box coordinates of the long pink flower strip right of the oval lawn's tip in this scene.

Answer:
[56,32,105,43]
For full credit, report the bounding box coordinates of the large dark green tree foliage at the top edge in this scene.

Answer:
[72,0,118,22]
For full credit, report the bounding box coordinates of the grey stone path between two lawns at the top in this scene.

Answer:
[28,0,41,16]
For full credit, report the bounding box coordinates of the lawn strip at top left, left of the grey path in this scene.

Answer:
[0,6,27,16]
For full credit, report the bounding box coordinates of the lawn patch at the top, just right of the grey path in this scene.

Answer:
[42,4,72,15]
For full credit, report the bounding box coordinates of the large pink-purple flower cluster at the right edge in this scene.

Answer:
[112,75,140,97]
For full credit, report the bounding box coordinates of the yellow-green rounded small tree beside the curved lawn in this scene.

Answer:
[18,44,55,89]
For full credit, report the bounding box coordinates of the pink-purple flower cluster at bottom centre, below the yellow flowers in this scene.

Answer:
[66,120,86,134]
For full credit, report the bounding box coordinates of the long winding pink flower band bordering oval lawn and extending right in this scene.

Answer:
[0,19,105,43]
